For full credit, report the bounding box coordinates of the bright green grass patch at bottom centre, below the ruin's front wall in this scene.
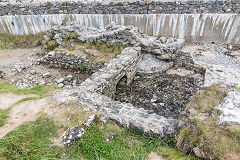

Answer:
[66,122,196,160]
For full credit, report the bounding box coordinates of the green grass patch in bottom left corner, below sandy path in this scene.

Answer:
[0,115,62,160]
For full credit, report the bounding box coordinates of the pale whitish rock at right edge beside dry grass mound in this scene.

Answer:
[216,90,240,126]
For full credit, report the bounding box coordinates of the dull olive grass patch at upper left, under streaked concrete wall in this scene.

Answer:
[0,33,44,49]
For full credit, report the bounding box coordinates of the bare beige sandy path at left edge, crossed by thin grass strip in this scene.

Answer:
[0,94,68,138]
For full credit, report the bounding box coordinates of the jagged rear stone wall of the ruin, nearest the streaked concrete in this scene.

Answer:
[45,23,185,60]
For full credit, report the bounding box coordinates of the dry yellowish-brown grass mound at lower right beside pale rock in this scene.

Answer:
[177,85,240,159]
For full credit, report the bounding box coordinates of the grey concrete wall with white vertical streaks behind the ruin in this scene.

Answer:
[0,14,240,44]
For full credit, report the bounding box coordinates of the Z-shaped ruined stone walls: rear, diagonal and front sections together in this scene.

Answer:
[49,24,203,138]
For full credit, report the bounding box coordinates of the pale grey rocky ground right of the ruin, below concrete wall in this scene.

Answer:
[183,45,240,87]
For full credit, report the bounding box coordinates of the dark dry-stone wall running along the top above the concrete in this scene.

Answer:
[0,0,240,16]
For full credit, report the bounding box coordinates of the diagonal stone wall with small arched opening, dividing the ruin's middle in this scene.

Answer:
[80,47,141,97]
